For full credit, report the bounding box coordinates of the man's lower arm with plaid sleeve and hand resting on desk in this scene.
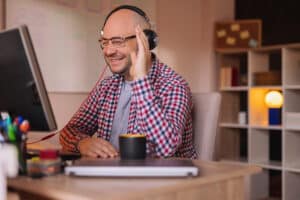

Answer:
[59,80,118,158]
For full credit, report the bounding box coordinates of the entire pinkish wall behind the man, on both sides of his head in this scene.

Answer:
[0,0,234,92]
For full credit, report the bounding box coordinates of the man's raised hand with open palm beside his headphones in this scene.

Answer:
[129,26,151,80]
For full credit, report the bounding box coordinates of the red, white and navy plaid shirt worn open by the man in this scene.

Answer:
[60,55,196,158]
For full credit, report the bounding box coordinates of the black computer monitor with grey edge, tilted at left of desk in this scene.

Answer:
[0,25,57,131]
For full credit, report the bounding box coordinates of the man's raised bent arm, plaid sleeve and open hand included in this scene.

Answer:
[130,26,192,157]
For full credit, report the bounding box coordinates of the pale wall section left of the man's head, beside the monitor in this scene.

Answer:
[6,0,156,92]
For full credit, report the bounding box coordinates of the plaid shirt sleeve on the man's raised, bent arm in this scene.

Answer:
[132,76,192,157]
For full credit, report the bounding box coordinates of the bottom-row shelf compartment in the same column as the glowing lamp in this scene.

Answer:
[250,169,282,200]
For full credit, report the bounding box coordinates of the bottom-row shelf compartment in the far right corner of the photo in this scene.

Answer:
[284,172,300,200]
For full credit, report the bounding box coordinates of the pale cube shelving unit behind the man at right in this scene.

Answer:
[217,44,300,200]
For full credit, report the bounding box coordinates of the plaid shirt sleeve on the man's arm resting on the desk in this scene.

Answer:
[59,86,99,152]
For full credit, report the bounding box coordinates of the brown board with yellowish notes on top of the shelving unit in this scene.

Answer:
[215,19,262,50]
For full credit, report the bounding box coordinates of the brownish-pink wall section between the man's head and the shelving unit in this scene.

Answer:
[157,0,234,92]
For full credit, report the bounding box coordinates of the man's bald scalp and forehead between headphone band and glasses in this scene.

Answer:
[103,9,150,37]
